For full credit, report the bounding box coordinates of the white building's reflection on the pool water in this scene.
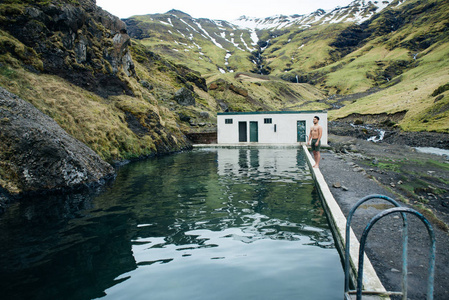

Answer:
[217,148,311,181]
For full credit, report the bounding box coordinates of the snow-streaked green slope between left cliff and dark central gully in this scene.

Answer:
[125,10,255,75]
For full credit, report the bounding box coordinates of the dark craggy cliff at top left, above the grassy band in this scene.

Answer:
[0,0,135,97]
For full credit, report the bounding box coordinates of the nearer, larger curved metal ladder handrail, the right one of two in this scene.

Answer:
[357,206,436,300]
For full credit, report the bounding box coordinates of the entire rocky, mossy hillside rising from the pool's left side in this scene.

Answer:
[0,0,198,213]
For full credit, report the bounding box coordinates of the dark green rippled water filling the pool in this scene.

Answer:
[0,148,343,300]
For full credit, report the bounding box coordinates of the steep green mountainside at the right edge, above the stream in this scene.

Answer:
[326,1,449,132]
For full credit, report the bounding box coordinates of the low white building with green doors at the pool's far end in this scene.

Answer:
[217,111,327,145]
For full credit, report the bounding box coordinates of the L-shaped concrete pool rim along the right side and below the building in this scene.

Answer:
[194,143,389,300]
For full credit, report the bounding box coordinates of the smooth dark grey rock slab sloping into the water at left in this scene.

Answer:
[0,87,115,195]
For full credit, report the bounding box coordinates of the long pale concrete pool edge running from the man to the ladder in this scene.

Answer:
[302,145,389,299]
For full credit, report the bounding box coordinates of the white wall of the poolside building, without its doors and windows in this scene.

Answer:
[217,112,327,145]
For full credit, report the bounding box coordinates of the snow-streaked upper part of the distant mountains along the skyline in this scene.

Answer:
[123,0,406,73]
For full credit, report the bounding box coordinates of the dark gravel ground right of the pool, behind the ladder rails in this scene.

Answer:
[320,134,449,300]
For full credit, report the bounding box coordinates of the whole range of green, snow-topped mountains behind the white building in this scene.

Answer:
[124,0,449,132]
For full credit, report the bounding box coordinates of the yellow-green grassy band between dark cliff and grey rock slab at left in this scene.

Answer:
[0,53,182,162]
